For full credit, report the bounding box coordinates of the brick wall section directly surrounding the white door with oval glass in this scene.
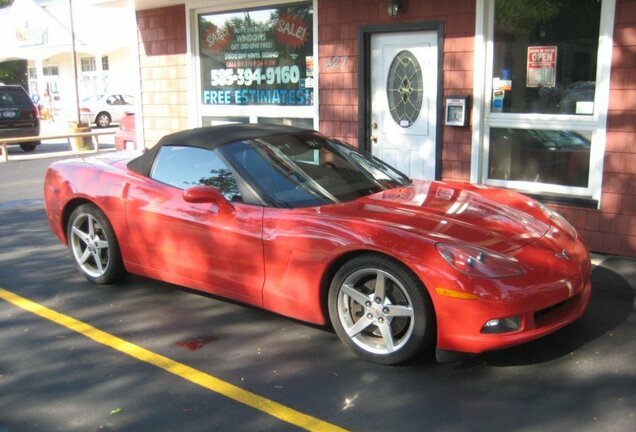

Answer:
[318,0,475,180]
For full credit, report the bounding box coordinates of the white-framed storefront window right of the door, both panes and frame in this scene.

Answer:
[471,0,616,205]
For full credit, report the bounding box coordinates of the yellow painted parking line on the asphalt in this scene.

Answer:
[0,287,345,432]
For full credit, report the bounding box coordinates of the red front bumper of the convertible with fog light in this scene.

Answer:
[432,230,591,354]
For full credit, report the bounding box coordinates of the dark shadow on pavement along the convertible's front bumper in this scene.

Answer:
[461,257,636,367]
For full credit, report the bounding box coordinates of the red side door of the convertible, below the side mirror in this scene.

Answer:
[120,170,264,306]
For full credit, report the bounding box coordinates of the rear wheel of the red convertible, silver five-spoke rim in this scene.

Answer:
[66,204,126,285]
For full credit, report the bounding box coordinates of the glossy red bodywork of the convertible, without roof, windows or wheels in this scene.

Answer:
[45,155,591,353]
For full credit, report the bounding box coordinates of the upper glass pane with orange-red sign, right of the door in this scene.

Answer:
[491,0,601,115]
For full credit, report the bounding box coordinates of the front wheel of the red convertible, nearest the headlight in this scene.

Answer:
[328,254,435,364]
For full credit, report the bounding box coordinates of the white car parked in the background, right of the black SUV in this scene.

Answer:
[80,93,135,127]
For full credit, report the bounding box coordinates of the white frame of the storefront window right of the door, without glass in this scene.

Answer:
[470,0,616,206]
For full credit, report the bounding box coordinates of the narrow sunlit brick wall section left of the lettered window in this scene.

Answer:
[137,5,188,147]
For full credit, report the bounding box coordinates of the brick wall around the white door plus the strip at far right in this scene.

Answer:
[318,0,636,256]
